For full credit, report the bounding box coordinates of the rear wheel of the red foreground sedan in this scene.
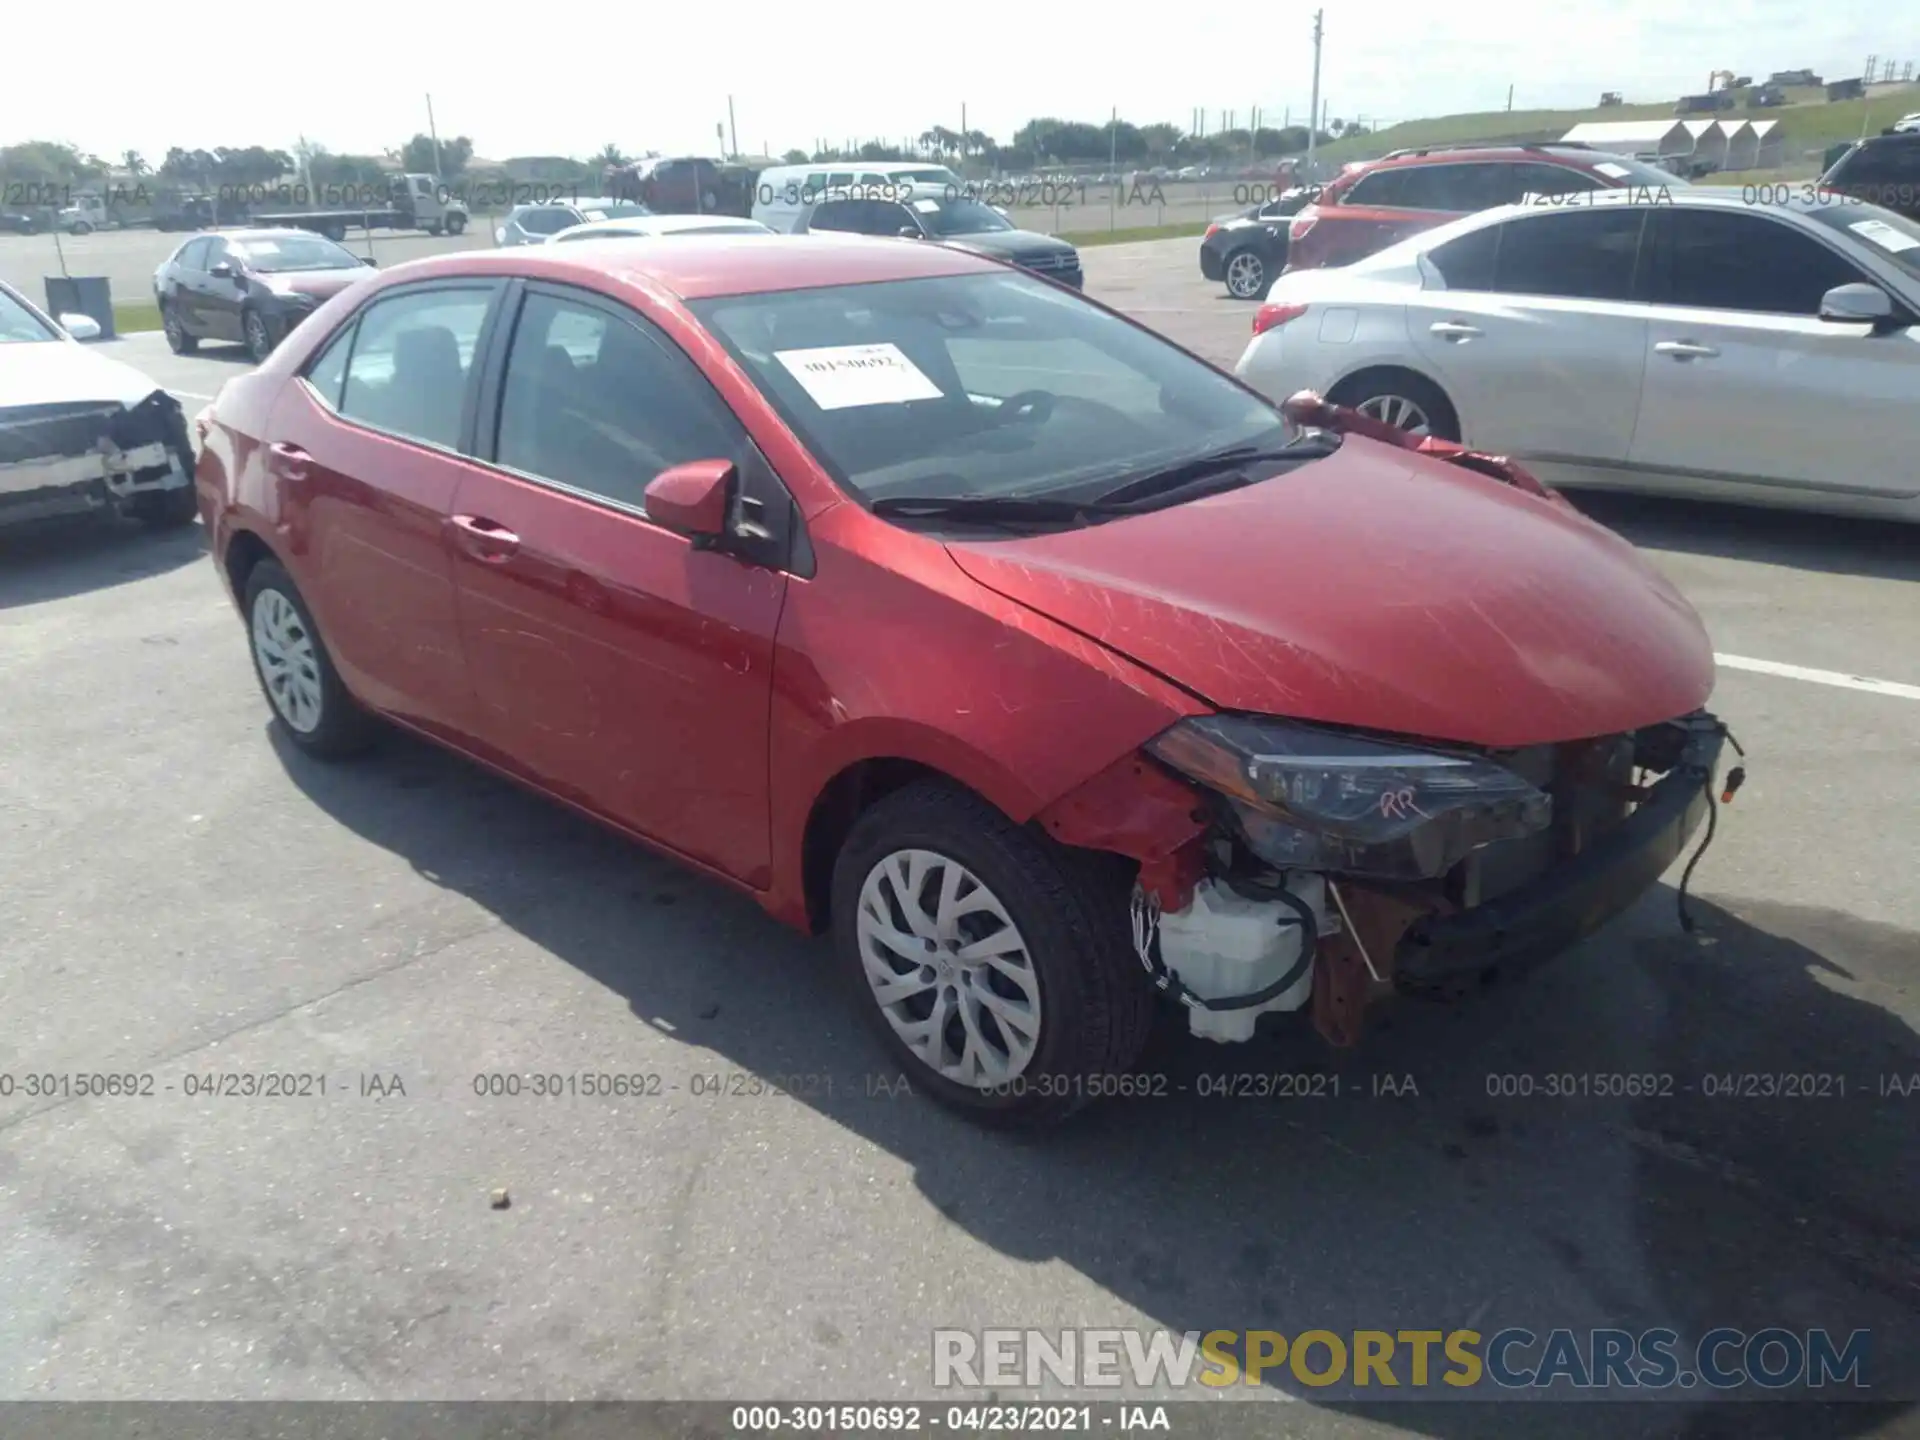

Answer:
[246,561,374,760]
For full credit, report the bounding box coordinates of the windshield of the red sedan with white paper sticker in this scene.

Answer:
[691,273,1286,514]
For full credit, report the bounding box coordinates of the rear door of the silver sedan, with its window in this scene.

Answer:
[1407,205,1647,464]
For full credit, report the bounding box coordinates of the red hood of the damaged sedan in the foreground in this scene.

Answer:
[948,436,1713,749]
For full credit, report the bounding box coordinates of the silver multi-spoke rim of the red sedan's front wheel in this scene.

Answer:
[854,849,1041,1091]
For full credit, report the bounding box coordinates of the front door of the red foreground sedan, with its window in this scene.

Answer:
[451,286,793,885]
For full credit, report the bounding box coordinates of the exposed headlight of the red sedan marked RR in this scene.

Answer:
[1146,714,1553,879]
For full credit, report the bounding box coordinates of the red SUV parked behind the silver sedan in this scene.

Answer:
[1286,144,1686,271]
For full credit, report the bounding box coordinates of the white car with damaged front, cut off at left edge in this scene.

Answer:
[0,284,196,528]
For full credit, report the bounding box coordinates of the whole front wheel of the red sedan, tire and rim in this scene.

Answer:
[833,781,1154,1125]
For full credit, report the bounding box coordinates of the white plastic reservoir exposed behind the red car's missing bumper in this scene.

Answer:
[1160,872,1338,1043]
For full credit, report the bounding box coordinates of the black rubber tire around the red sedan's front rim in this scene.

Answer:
[833,781,1154,1125]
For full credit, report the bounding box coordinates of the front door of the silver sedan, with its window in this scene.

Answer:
[1630,207,1920,495]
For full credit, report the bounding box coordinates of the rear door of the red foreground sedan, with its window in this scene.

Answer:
[263,278,503,745]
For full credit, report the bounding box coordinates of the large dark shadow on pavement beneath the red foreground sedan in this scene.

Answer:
[275,732,1920,1440]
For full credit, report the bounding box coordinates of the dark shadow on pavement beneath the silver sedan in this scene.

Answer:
[1567,490,1920,580]
